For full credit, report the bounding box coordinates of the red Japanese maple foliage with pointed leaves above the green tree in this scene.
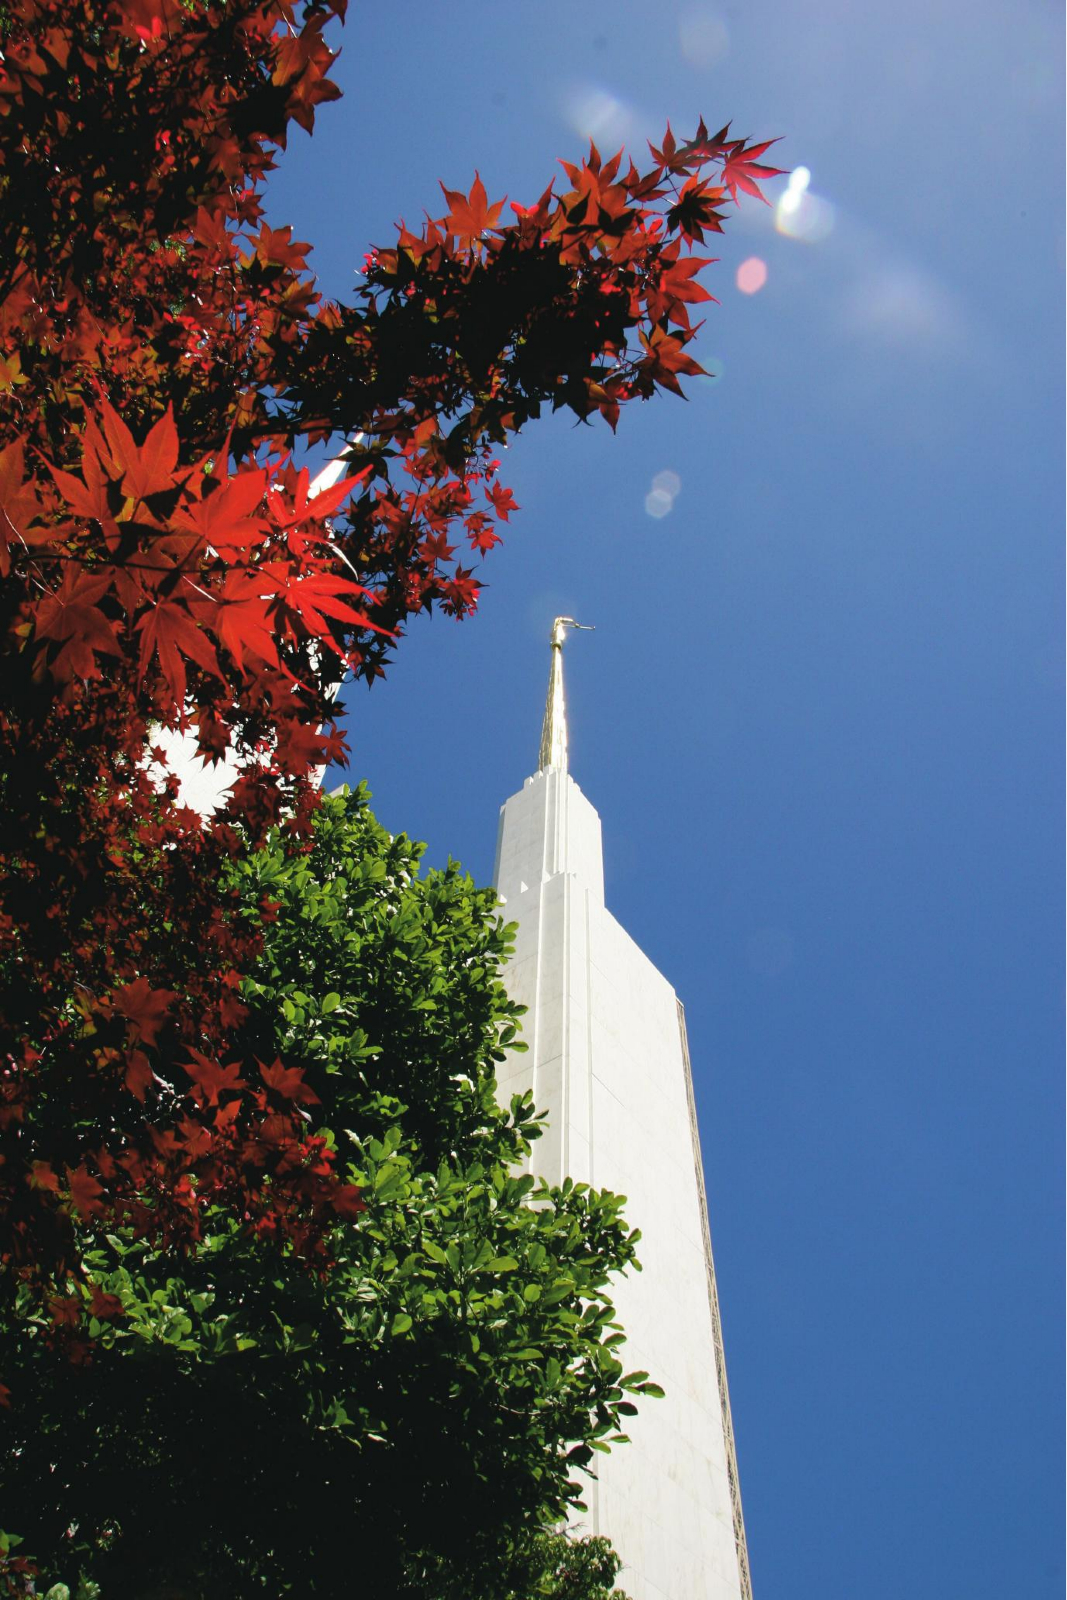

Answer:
[0,0,774,1376]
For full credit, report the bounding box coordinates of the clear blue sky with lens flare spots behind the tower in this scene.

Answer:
[270,0,1064,1600]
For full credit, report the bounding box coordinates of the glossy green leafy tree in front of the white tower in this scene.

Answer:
[0,790,654,1600]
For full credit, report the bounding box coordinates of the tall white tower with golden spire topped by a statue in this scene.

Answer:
[494,618,752,1600]
